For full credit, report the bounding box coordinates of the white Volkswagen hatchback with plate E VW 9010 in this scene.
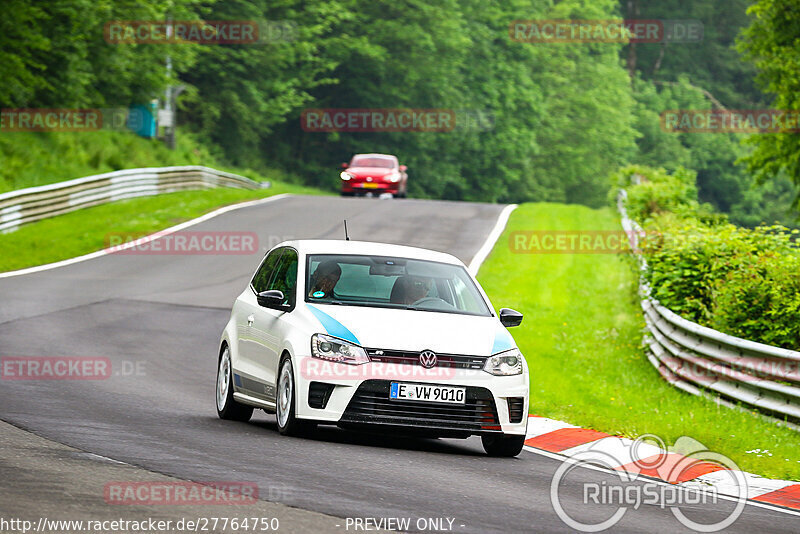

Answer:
[216,240,529,456]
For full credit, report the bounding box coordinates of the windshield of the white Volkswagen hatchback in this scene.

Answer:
[306,254,491,316]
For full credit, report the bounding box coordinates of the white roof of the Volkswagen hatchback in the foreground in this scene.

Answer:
[276,239,463,265]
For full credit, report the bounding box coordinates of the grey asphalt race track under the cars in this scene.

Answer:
[0,197,800,533]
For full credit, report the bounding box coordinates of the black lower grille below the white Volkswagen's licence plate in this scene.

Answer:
[340,380,500,434]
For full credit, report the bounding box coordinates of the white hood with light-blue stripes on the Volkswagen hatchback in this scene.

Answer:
[305,303,516,356]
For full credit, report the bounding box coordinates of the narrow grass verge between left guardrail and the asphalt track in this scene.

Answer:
[0,182,321,272]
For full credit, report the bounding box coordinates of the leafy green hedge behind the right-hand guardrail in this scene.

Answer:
[614,167,800,349]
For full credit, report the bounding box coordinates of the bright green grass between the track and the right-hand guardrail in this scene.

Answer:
[479,204,800,480]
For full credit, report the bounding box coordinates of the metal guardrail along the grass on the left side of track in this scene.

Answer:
[0,165,270,233]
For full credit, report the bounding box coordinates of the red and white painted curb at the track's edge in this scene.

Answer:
[525,415,800,510]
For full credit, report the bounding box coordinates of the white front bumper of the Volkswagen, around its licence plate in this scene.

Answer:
[297,358,529,436]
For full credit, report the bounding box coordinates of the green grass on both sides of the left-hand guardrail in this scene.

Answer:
[0,127,322,272]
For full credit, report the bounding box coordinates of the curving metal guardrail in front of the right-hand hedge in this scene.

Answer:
[617,190,800,430]
